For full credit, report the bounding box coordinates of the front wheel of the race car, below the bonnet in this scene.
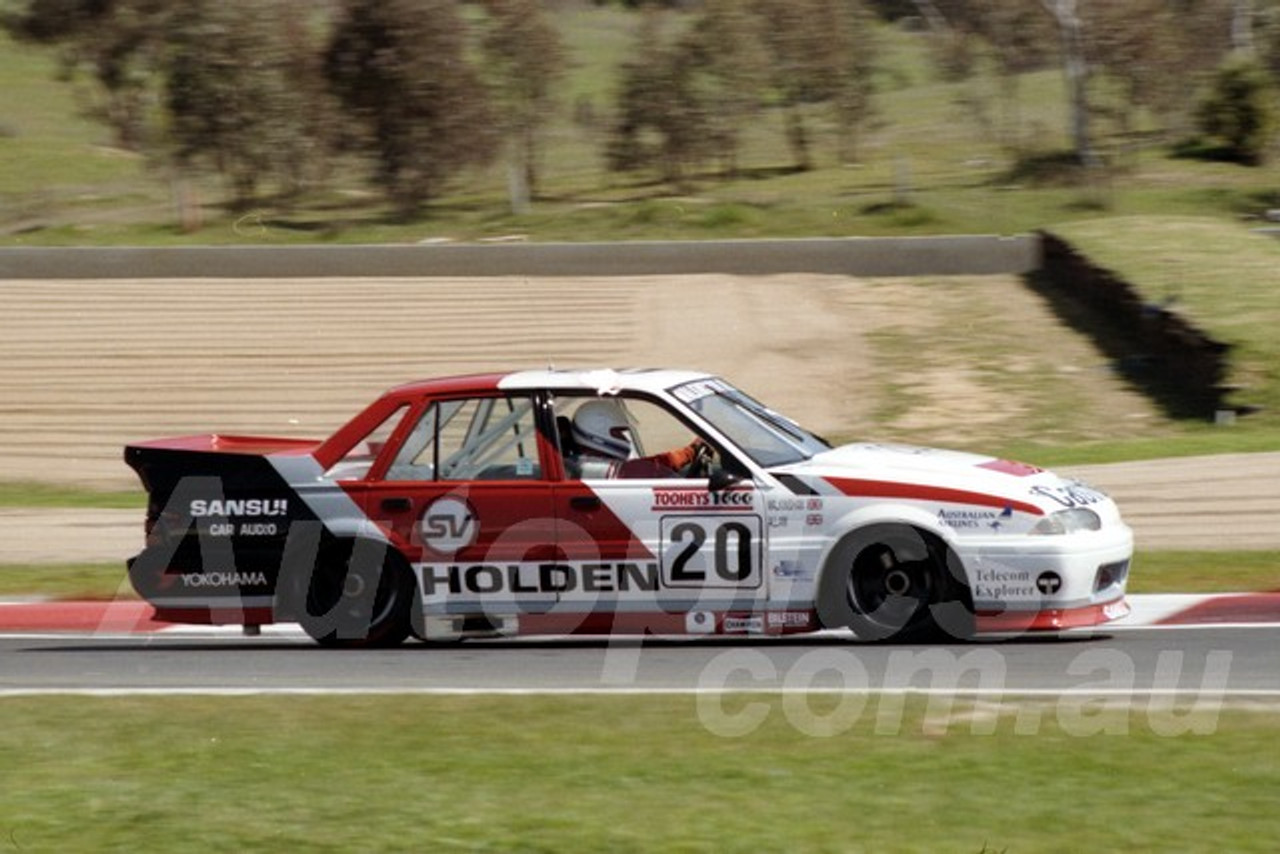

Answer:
[818,525,973,643]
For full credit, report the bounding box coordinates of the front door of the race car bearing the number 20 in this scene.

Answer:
[553,394,768,629]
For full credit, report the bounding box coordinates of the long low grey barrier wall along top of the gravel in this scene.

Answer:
[0,236,1041,280]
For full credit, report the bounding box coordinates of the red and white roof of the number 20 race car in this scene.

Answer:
[387,367,712,397]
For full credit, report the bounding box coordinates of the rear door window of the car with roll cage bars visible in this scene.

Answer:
[387,397,541,480]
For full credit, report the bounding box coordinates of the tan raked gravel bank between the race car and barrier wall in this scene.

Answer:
[0,275,1149,488]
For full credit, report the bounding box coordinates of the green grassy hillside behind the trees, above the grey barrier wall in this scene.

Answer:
[0,3,1280,245]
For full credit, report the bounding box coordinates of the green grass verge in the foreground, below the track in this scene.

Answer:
[0,696,1280,854]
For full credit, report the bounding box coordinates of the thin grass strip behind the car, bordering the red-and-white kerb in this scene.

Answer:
[0,551,1280,599]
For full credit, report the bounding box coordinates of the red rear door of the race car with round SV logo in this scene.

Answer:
[345,394,557,615]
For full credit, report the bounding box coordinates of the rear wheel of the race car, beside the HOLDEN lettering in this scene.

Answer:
[294,540,415,648]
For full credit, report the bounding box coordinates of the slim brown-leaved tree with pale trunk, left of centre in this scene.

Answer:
[483,0,564,213]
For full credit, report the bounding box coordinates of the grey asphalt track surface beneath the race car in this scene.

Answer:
[0,624,1280,705]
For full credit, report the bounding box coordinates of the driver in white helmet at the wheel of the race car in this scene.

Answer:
[566,401,710,478]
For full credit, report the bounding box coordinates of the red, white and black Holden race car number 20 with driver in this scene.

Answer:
[124,369,1133,647]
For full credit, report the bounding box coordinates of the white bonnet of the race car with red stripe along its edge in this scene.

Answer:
[774,443,1119,519]
